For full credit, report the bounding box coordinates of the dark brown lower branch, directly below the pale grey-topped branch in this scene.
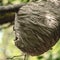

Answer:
[0,12,15,25]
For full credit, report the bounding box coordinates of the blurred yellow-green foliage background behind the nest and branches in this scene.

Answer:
[0,0,60,60]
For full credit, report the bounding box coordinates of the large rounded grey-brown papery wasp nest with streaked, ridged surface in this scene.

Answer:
[14,2,60,56]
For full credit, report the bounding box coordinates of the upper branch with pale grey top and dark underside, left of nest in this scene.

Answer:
[0,3,26,14]
